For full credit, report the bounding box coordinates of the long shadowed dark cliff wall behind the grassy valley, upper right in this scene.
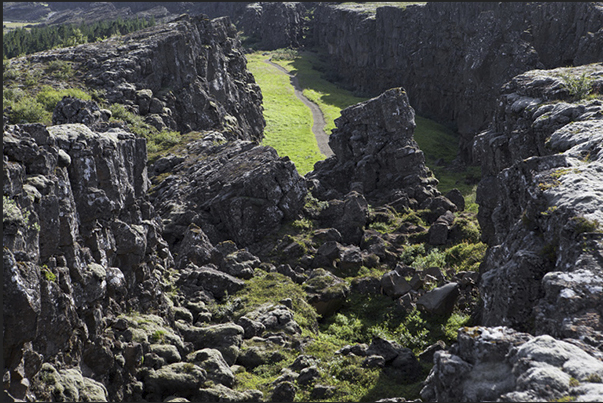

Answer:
[312,2,603,161]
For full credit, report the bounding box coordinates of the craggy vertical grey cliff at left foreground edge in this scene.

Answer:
[3,119,173,400]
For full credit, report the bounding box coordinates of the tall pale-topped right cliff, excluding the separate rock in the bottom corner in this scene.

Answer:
[475,64,603,344]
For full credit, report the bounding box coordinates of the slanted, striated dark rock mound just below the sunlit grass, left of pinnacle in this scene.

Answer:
[153,137,307,247]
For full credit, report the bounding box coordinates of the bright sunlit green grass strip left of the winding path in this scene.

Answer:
[247,53,325,175]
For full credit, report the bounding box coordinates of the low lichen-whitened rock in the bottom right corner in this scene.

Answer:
[421,326,603,402]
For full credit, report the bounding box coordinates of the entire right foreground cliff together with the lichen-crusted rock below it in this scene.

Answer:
[421,63,603,401]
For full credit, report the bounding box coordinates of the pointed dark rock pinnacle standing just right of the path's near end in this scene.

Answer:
[306,88,442,210]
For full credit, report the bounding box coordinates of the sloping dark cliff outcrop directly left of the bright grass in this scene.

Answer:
[21,15,265,141]
